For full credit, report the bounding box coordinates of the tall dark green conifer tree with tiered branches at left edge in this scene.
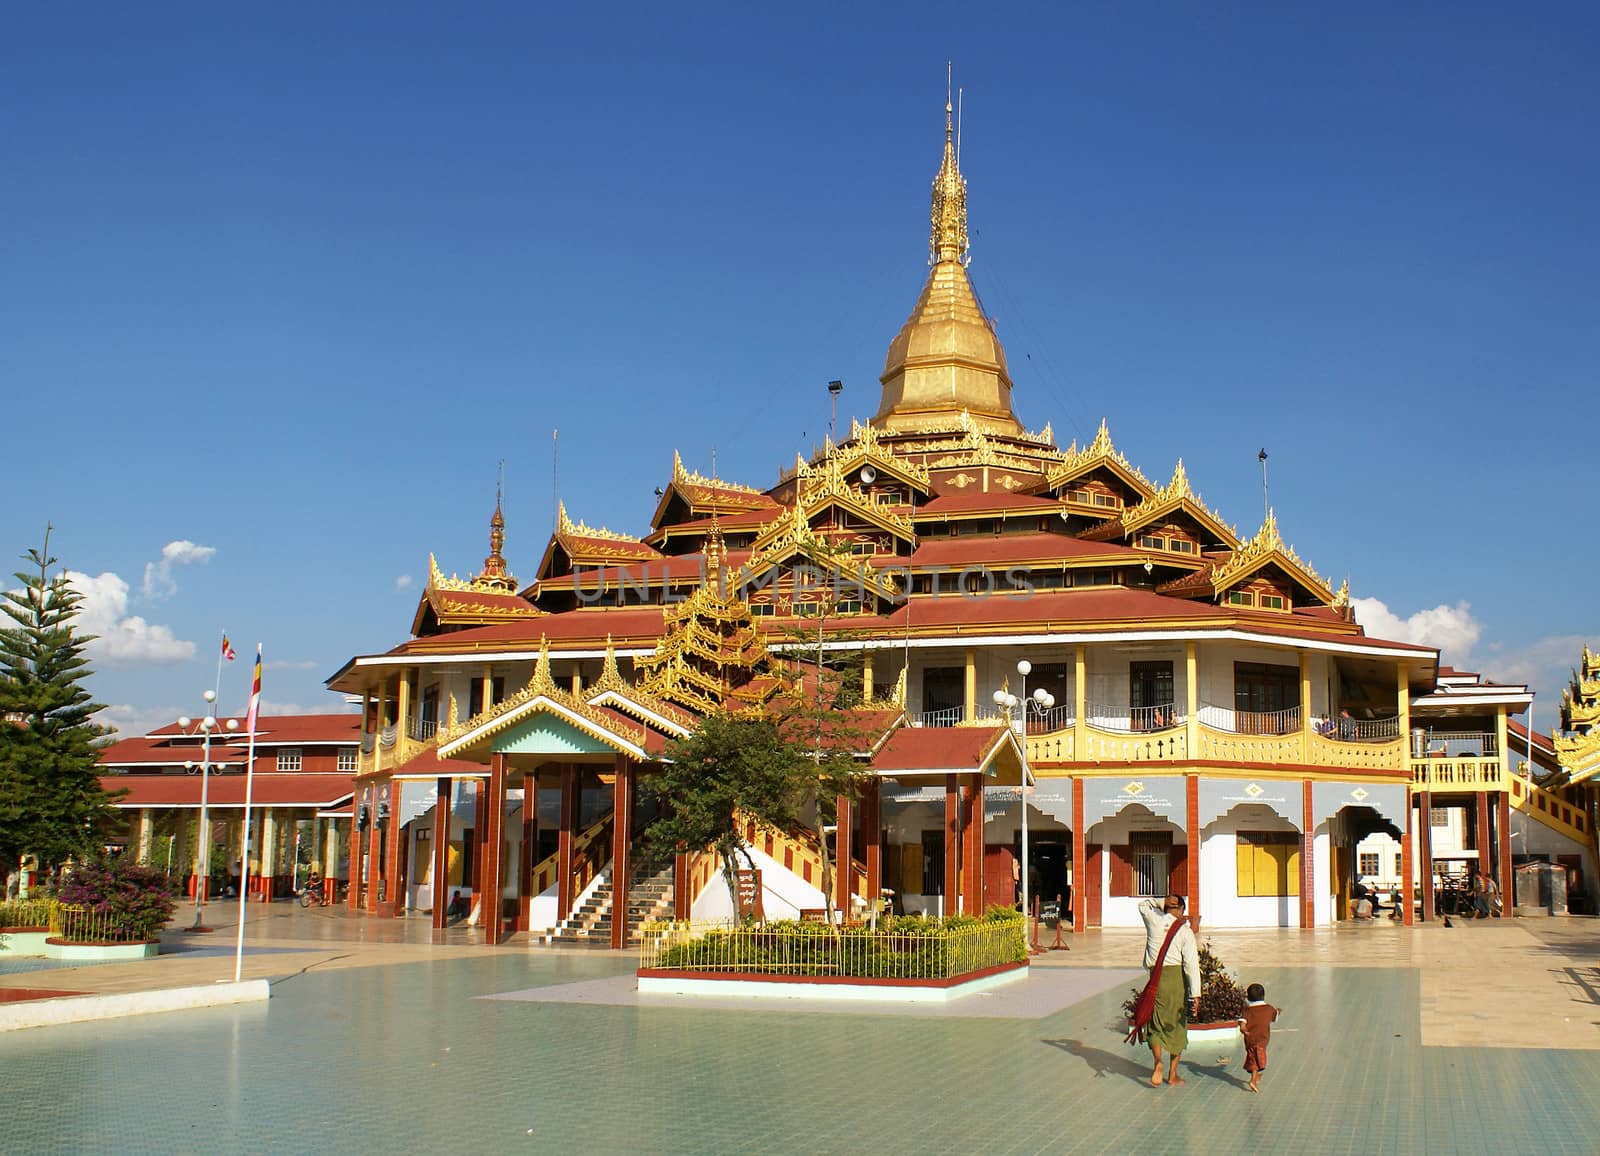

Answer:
[0,527,110,869]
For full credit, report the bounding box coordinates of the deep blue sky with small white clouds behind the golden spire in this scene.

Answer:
[0,3,1600,727]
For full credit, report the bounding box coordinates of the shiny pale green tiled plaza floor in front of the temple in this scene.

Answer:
[0,929,1600,1153]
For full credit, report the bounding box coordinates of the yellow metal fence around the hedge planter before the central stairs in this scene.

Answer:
[638,916,1027,980]
